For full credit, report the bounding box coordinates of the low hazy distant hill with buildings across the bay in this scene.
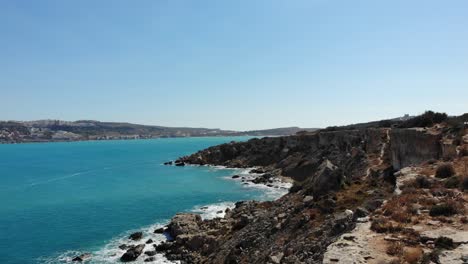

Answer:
[0,120,315,143]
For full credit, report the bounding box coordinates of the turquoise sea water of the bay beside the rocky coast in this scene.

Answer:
[0,137,282,264]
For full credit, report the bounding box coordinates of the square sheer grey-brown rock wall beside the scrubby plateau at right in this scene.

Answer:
[390,129,442,170]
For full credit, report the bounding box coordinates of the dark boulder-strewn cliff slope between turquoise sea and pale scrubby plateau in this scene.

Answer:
[164,129,393,264]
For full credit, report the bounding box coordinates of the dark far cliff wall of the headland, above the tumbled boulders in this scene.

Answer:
[179,129,385,181]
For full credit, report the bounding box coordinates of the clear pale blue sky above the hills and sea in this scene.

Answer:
[0,0,468,130]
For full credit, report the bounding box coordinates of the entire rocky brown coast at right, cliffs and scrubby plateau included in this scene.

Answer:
[71,116,468,264]
